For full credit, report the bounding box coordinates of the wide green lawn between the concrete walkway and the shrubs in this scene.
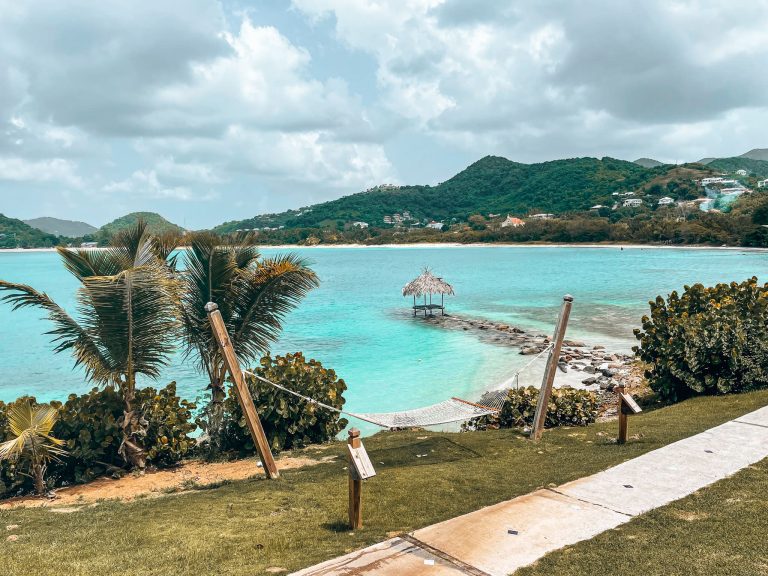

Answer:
[0,391,768,576]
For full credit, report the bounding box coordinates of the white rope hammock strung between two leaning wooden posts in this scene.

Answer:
[243,344,552,428]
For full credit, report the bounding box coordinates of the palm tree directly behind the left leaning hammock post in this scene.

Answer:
[181,232,319,450]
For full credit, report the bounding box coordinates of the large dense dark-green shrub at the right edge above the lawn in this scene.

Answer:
[634,277,768,400]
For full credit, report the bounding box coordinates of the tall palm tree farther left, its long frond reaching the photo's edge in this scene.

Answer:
[0,222,179,468]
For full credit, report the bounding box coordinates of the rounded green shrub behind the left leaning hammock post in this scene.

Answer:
[200,352,347,455]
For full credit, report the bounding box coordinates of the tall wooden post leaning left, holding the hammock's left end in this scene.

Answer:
[205,302,280,479]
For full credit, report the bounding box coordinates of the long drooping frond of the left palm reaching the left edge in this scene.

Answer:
[0,280,113,382]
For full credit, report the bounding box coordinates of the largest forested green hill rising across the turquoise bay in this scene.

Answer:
[215,156,711,233]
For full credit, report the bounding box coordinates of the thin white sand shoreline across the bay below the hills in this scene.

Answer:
[0,242,768,254]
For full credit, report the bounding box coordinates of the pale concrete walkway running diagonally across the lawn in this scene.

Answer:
[295,406,768,576]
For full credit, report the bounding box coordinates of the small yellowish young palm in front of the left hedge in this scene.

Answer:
[0,400,66,494]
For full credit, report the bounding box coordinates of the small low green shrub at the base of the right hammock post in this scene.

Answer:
[464,386,599,430]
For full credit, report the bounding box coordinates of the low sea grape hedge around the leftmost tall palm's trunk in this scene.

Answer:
[0,382,196,497]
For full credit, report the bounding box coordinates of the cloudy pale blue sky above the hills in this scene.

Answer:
[0,0,768,228]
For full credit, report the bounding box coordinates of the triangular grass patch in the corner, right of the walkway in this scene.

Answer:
[515,459,768,576]
